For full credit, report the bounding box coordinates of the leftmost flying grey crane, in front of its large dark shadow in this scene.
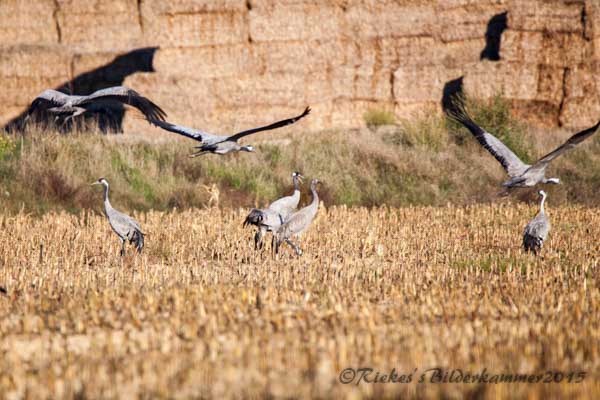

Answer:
[26,86,167,122]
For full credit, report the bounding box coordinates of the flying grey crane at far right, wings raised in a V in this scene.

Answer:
[448,105,600,188]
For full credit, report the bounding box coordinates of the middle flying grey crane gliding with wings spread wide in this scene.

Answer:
[151,107,310,157]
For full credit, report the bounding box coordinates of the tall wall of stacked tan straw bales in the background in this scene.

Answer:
[0,0,600,131]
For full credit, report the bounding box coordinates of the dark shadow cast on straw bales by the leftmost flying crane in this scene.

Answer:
[3,47,158,133]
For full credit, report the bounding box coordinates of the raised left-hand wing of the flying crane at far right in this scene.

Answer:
[448,107,529,177]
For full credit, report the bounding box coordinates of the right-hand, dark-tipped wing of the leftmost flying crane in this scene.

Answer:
[77,86,167,121]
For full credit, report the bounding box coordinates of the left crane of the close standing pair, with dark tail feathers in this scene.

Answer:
[243,172,303,249]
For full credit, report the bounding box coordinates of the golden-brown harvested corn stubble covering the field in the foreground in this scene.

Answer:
[0,204,600,399]
